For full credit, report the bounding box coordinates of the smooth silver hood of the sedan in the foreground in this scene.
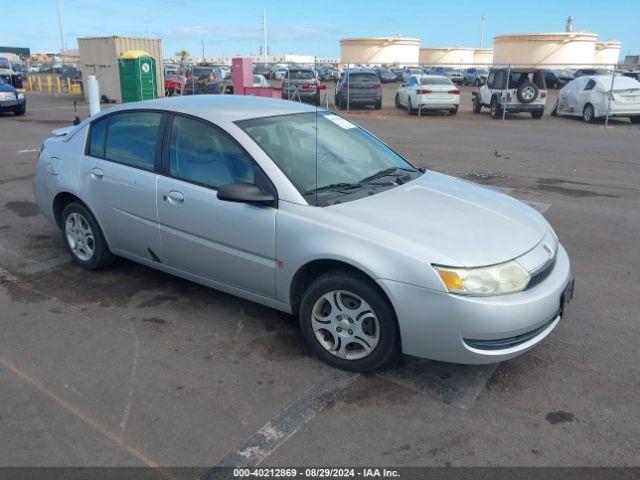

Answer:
[328,171,548,267]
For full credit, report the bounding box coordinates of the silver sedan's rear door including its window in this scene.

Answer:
[81,111,164,260]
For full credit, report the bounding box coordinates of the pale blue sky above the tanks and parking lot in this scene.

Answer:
[5,0,640,56]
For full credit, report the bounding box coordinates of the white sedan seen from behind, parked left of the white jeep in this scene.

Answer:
[396,75,460,115]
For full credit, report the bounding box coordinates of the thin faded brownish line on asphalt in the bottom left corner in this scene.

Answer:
[0,357,175,479]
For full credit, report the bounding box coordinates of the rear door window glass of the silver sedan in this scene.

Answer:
[104,112,162,170]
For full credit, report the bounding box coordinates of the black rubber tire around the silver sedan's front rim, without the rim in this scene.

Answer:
[299,270,399,372]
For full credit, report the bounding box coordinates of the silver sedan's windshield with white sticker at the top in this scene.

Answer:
[237,111,422,206]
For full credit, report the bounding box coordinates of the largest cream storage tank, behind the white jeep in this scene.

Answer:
[493,32,598,68]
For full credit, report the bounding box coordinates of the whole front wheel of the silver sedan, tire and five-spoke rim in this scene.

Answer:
[300,270,398,372]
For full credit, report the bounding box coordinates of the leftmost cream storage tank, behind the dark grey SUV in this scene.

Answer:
[340,37,420,65]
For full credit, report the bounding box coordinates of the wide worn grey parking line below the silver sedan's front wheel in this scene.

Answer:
[211,370,359,468]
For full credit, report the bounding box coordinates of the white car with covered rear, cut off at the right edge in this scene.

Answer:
[551,75,640,123]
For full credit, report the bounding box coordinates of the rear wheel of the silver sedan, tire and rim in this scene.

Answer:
[61,202,115,270]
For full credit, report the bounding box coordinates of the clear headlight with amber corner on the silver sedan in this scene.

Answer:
[433,260,531,295]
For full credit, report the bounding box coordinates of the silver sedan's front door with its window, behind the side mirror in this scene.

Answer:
[157,115,277,298]
